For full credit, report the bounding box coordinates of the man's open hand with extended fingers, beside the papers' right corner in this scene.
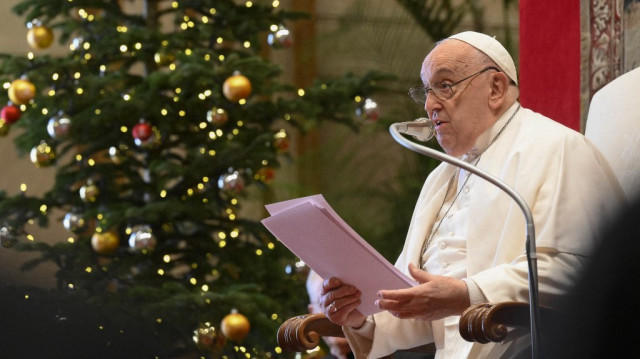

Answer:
[376,264,470,320]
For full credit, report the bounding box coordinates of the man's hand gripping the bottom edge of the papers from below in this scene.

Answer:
[320,278,365,328]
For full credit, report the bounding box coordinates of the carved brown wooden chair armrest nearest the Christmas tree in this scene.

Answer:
[278,314,344,352]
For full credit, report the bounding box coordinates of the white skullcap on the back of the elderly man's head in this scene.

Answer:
[449,31,518,85]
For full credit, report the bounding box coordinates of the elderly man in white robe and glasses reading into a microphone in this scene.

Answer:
[320,32,623,358]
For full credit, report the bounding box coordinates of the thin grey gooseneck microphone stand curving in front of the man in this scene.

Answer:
[389,123,540,359]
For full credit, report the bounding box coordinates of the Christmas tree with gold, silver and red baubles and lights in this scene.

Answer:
[0,0,385,358]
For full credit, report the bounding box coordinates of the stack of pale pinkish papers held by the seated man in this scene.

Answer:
[262,195,416,315]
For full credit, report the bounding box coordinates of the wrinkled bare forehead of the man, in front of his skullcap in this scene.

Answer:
[420,39,474,84]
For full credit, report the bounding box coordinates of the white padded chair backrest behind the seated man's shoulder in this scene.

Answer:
[585,68,640,200]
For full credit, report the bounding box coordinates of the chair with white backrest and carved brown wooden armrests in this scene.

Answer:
[278,68,640,351]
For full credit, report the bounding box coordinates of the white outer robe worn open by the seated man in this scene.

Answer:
[345,103,624,359]
